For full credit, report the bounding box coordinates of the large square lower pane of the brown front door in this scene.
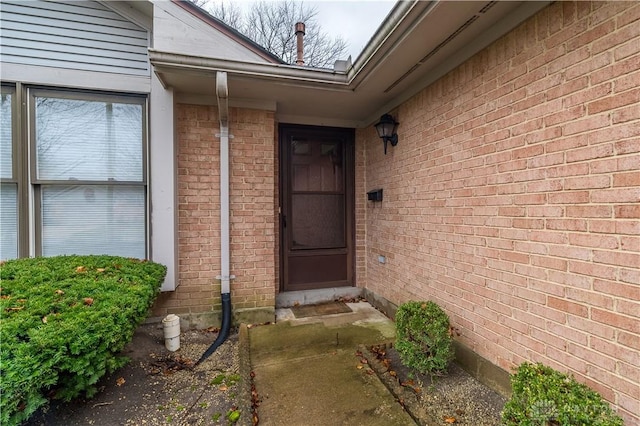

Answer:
[291,194,345,250]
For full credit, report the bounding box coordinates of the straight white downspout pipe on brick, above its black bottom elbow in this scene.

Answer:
[216,71,234,293]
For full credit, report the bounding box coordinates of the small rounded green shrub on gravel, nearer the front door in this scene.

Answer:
[396,301,454,374]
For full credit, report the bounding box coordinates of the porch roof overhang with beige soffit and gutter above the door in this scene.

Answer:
[149,1,550,128]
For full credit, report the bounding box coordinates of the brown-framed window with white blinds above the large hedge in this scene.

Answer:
[1,85,147,259]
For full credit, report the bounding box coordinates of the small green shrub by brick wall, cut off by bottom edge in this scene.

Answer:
[502,363,623,426]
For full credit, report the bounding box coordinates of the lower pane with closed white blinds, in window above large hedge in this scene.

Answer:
[42,185,145,259]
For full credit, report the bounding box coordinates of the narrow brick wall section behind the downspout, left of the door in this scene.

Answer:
[154,105,277,322]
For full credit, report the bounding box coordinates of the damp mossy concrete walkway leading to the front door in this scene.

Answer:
[248,302,415,426]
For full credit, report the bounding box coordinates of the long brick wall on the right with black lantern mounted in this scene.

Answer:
[357,2,640,424]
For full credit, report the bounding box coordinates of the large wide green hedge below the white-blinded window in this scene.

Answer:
[0,256,166,425]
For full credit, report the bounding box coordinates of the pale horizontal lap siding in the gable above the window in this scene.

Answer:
[0,0,150,76]
